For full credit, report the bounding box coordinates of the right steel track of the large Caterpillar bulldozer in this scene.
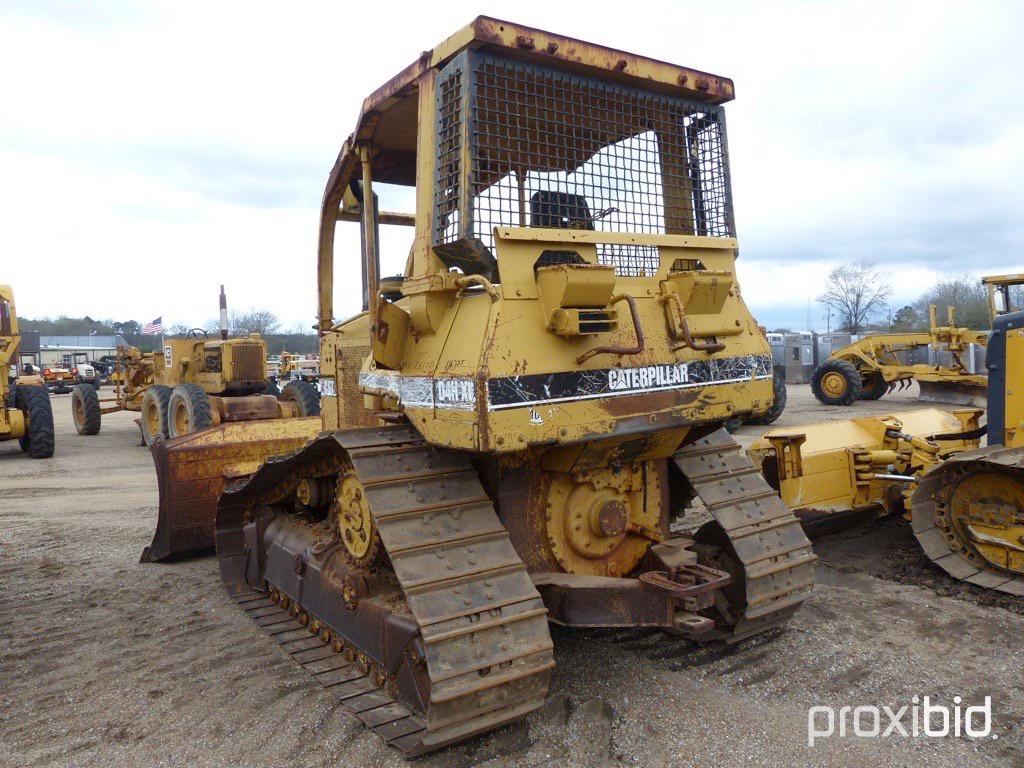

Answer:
[673,429,817,642]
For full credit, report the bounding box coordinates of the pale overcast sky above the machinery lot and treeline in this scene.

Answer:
[0,0,1024,328]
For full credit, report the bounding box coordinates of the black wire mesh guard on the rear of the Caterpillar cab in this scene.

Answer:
[434,51,734,275]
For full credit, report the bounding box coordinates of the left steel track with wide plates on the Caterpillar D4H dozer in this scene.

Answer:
[216,426,554,757]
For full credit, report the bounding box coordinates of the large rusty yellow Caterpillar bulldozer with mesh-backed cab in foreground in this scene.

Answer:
[154,17,815,755]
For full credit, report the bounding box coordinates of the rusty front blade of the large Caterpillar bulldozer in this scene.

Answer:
[140,416,322,562]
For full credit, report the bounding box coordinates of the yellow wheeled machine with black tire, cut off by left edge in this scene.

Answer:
[0,286,54,459]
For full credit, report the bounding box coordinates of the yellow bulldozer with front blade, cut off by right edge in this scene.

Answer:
[749,275,1024,596]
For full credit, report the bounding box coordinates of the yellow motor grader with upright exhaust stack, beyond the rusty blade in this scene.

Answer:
[72,286,319,445]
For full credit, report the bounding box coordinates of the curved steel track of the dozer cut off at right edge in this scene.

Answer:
[910,449,1024,597]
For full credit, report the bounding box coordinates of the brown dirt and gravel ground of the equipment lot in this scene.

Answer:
[0,386,1024,768]
